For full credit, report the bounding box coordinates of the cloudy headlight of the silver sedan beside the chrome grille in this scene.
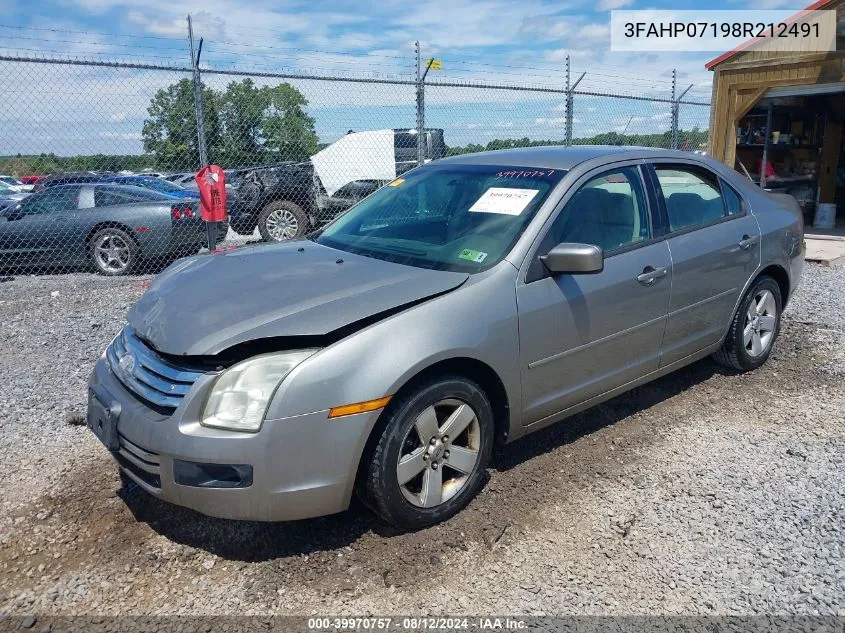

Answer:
[200,349,317,433]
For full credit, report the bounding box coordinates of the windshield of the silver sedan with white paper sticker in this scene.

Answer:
[314,163,565,272]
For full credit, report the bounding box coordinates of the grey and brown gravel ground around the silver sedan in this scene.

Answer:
[0,266,845,616]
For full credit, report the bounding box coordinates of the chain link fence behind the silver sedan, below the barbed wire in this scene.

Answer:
[0,56,709,275]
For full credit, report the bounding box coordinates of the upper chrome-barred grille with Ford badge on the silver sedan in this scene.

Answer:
[106,325,202,413]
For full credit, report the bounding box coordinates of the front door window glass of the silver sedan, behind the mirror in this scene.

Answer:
[546,167,651,252]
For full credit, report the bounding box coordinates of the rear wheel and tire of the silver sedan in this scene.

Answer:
[713,276,783,371]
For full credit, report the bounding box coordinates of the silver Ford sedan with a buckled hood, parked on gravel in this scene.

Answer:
[88,147,803,529]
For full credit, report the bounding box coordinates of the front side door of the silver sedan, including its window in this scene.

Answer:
[517,165,672,424]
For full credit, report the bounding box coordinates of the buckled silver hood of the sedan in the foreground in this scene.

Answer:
[129,241,468,355]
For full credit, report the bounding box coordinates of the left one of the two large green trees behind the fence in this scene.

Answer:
[141,79,221,171]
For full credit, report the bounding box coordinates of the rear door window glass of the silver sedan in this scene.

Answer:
[654,165,725,231]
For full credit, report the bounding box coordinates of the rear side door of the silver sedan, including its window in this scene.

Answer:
[651,161,760,367]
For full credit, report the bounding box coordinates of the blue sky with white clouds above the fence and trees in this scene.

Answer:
[0,0,794,154]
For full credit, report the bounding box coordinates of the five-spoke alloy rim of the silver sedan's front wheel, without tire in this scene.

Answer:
[396,398,481,508]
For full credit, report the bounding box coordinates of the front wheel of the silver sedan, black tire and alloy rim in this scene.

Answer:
[363,376,495,530]
